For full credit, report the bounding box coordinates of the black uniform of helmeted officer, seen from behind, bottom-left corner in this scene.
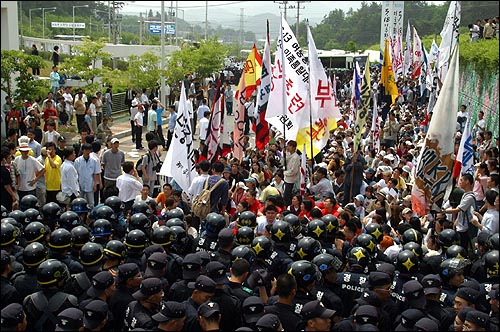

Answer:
[23,288,78,331]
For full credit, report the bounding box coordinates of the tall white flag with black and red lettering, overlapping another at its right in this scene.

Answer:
[266,18,309,140]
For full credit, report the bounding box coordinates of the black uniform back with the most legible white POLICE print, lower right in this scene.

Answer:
[337,268,368,317]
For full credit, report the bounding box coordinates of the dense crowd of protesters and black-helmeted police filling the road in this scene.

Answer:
[1,58,499,331]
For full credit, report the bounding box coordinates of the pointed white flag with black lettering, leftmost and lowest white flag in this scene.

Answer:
[160,82,198,190]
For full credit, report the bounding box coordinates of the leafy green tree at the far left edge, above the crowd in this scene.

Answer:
[1,50,50,106]
